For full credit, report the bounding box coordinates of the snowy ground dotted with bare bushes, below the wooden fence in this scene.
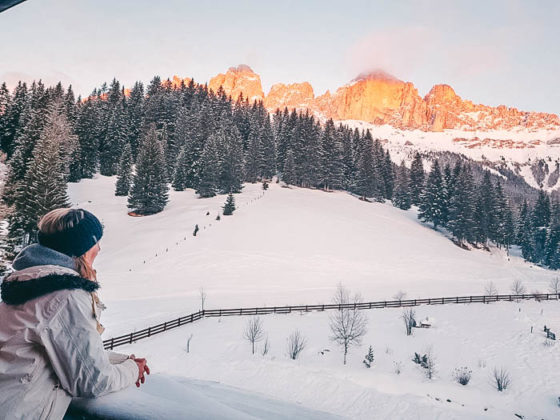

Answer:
[118,301,560,420]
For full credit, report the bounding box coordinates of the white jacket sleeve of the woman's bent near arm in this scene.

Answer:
[42,290,138,398]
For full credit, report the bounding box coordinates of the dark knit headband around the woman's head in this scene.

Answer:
[38,209,103,257]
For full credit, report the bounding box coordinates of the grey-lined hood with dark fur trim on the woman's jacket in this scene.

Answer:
[0,244,99,305]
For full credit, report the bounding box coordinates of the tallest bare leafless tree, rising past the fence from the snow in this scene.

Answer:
[329,284,367,364]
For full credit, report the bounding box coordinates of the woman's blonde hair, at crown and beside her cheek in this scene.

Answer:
[37,208,97,281]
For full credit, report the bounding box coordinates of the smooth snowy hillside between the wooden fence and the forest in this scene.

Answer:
[69,176,556,338]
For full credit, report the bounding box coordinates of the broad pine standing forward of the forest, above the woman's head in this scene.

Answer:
[128,125,169,215]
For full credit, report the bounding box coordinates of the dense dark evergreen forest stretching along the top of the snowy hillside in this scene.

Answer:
[0,77,560,268]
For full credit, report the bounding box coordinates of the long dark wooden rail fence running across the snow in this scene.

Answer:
[103,293,560,350]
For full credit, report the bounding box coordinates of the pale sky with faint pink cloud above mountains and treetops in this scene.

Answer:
[0,0,560,114]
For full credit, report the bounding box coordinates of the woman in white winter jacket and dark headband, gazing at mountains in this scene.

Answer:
[0,209,149,419]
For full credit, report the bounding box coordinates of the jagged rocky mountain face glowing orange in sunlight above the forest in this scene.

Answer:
[209,65,560,131]
